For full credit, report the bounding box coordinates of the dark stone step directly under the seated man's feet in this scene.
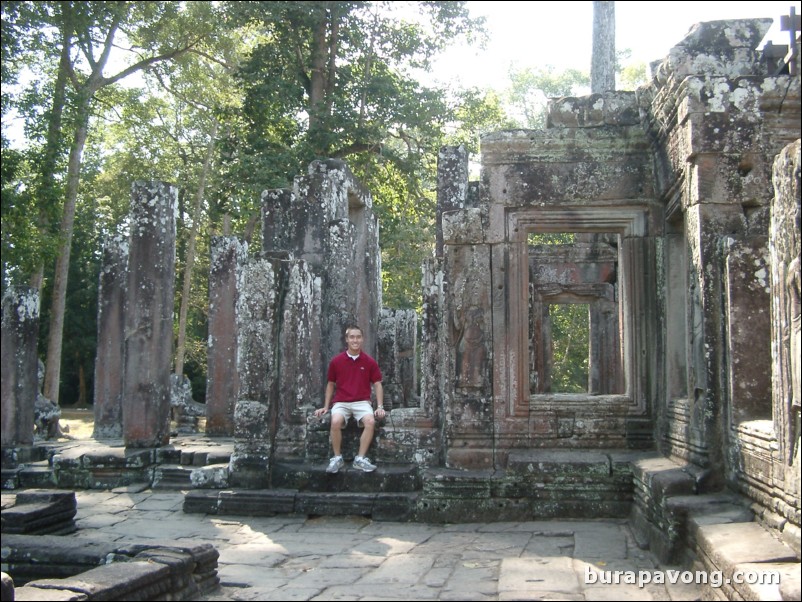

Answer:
[271,460,421,493]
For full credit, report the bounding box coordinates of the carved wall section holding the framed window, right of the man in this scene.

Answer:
[424,92,663,469]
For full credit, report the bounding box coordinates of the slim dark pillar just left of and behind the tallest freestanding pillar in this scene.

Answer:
[93,235,128,439]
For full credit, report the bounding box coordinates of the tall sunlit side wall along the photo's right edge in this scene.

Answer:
[639,19,800,549]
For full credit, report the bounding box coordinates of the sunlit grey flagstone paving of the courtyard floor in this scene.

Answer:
[76,490,702,600]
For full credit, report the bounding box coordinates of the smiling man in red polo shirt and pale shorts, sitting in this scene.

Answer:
[315,326,384,474]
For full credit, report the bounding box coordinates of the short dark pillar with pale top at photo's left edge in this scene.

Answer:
[0,286,39,447]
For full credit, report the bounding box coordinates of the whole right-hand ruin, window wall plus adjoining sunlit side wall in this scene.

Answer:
[422,14,800,542]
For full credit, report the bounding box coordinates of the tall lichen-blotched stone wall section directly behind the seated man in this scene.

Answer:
[228,160,410,486]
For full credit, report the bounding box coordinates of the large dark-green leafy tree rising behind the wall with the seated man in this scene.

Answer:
[223,1,492,306]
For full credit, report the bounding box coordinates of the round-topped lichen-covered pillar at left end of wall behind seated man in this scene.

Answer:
[229,258,278,488]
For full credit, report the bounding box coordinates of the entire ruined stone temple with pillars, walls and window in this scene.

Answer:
[2,14,801,599]
